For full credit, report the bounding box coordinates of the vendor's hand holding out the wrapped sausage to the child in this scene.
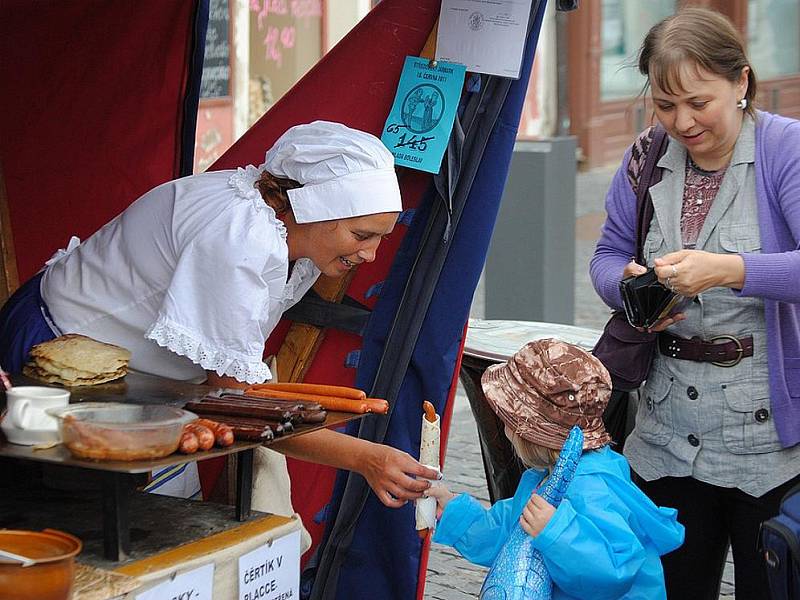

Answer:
[359,443,440,508]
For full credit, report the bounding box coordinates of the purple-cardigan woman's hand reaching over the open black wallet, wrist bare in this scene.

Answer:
[655,250,744,297]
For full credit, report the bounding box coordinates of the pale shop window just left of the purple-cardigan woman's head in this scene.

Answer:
[600,0,676,100]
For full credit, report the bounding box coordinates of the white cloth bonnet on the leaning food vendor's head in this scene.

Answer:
[260,121,403,223]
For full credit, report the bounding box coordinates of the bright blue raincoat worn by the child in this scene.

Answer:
[433,446,684,600]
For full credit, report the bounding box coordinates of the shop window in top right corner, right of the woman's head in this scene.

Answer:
[747,0,800,79]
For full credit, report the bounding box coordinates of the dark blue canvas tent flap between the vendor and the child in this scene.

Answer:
[304,0,546,600]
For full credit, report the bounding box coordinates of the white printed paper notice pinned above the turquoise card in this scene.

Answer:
[436,0,532,79]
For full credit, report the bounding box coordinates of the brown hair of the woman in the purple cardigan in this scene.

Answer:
[639,8,756,115]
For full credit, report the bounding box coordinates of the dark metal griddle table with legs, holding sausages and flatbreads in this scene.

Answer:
[0,372,364,561]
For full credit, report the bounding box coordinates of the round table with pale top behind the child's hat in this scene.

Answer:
[459,319,602,504]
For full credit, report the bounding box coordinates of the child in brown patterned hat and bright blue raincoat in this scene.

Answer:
[428,339,684,600]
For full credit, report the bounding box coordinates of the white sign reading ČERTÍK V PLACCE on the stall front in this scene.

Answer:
[239,531,300,600]
